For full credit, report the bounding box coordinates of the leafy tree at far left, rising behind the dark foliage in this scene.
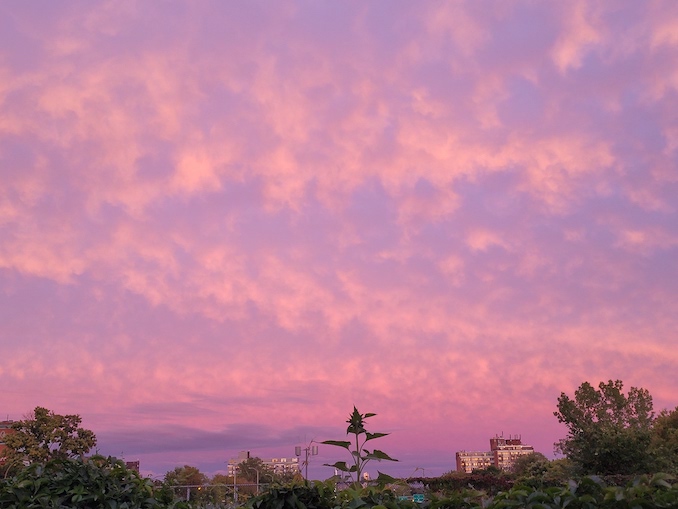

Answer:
[3,407,97,472]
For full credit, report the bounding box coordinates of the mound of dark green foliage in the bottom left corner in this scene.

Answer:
[0,456,161,509]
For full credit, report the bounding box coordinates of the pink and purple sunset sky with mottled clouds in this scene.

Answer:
[0,0,678,479]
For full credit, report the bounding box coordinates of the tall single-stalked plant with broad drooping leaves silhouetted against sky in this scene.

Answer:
[321,406,398,484]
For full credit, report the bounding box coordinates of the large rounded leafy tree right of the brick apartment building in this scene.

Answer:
[554,380,654,474]
